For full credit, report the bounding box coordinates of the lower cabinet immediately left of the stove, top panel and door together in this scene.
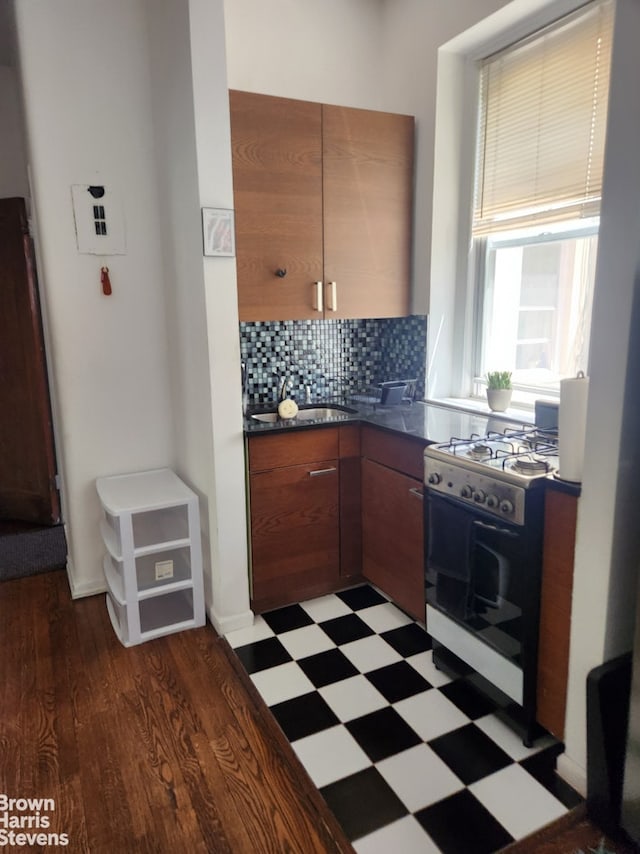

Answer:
[362,427,425,623]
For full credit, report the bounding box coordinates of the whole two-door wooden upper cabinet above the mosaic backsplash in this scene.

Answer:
[230,91,414,320]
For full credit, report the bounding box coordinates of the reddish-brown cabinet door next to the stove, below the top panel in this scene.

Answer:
[362,459,425,622]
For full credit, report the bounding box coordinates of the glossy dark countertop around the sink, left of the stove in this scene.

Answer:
[244,400,522,443]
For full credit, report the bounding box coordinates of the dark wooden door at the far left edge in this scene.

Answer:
[0,199,60,525]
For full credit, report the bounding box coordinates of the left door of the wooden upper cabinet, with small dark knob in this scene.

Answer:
[230,91,322,320]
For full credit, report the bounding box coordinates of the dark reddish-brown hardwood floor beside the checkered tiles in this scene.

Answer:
[0,571,353,854]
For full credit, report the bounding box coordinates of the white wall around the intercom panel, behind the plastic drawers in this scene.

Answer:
[16,0,174,595]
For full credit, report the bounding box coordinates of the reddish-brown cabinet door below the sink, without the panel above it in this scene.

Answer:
[250,459,340,609]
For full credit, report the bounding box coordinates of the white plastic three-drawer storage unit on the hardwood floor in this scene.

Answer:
[96,469,205,646]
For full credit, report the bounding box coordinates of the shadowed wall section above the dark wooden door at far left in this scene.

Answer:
[0,65,29,198]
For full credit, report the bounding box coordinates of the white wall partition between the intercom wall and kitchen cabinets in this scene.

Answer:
[147,0,252,632]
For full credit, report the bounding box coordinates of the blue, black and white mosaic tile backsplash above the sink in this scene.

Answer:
[240,315,427,406]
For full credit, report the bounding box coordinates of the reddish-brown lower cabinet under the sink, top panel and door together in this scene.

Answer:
[248,425,360,612]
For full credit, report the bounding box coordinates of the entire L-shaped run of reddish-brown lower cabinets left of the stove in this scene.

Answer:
[247,424,425,622]
